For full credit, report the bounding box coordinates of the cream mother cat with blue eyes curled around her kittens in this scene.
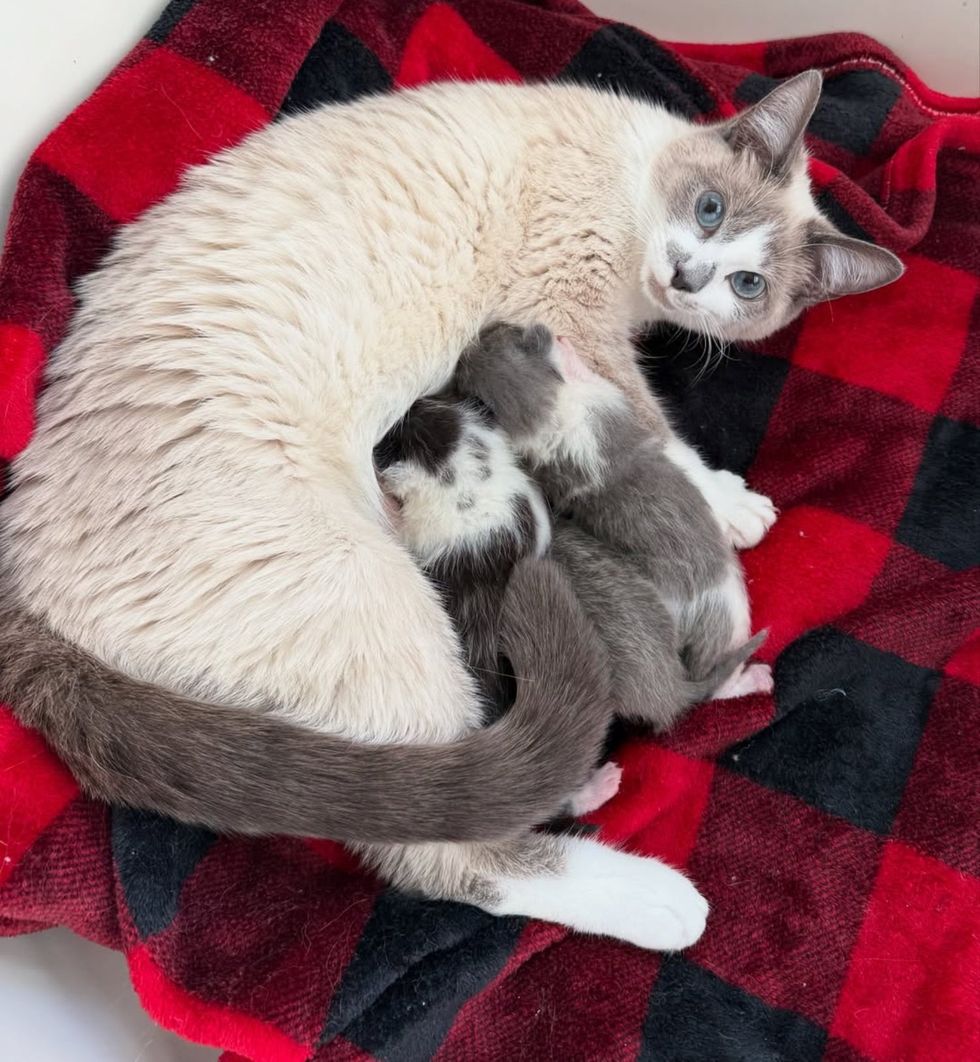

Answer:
[0,73,900,947]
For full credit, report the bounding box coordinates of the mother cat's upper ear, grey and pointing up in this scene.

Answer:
[722,70,823,176]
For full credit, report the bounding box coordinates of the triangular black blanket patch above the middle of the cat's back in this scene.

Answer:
[280,22,392,115]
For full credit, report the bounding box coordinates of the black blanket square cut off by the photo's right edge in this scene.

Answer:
[895,416,980,571]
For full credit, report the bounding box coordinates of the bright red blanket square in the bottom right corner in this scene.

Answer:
[830,841,980,1062]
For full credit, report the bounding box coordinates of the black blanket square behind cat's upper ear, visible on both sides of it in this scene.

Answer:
[735,70,901,155]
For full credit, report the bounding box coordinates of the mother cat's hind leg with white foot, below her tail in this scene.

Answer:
[366,834,708,952]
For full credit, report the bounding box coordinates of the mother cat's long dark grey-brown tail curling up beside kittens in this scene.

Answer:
[0,560,611,843]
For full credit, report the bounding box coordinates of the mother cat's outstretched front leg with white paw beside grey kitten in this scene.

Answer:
[587,342,776,549]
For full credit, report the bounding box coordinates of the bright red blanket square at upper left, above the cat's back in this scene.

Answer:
[37,48,269,221]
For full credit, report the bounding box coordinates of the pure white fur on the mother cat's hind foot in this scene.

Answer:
[491,838,708,952]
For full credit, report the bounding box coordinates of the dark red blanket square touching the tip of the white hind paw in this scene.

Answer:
[686,768,881,1025]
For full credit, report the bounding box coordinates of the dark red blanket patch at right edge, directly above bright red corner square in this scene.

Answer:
[892,678,980,879]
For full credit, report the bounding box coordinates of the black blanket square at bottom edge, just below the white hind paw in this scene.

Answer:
[639,955,826,1062]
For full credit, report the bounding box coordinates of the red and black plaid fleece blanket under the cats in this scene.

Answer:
[0,0,980,1062]
